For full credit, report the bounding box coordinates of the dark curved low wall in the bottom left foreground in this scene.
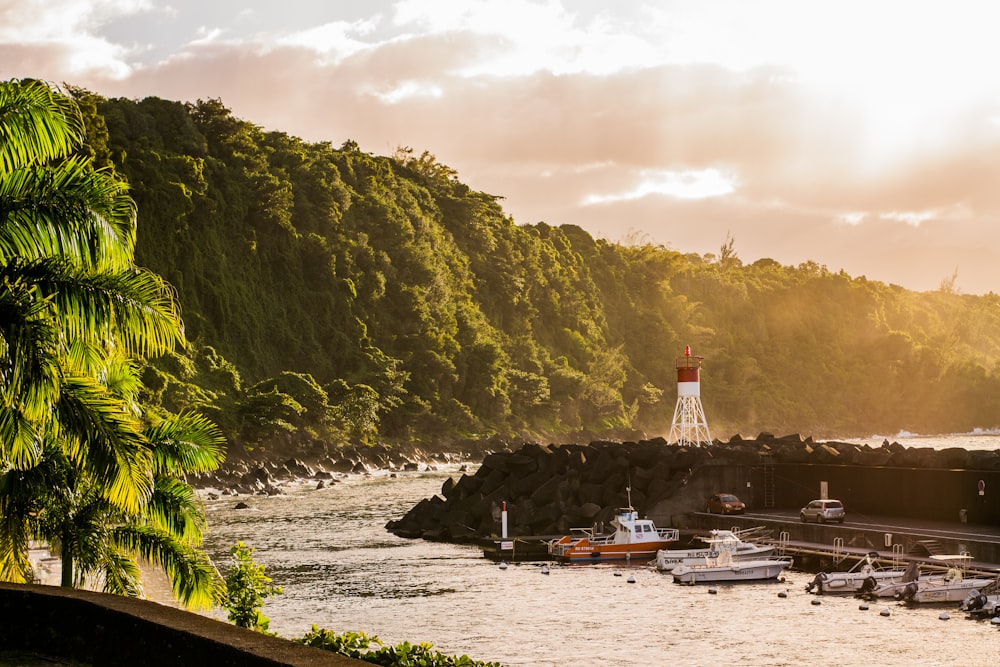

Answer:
[0,583,369,667]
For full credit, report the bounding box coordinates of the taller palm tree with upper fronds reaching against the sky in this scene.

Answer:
[0,82,183,486]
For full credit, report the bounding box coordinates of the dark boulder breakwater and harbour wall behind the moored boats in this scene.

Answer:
[386,433,1000,542]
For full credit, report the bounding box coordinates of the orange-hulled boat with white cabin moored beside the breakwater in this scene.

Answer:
[548,505,680,563]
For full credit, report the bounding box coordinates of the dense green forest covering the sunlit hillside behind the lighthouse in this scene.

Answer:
[73,90,1000,451]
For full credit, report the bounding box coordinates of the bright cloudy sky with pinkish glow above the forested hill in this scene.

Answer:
[0,0,1000,294]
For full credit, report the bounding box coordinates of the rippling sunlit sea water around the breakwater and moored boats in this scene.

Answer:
[197,434,1000,667]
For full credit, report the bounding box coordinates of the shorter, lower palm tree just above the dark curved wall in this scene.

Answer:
[0,413,223,608]
